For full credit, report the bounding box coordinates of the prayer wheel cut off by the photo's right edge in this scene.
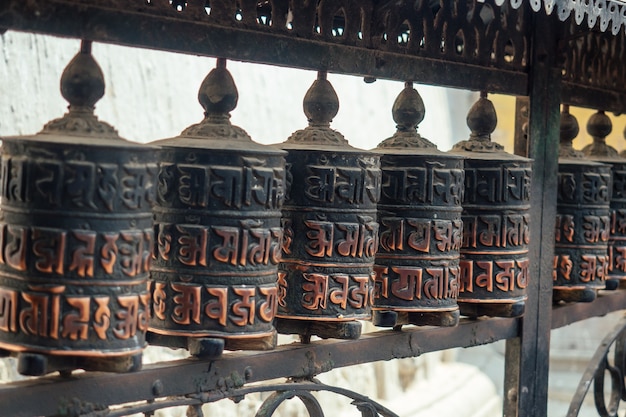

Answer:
[582,111,626,289]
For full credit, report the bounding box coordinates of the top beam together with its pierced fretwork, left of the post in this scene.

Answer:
[0,0,529,95]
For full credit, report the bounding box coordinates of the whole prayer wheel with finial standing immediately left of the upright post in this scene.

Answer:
[451,93,532,317]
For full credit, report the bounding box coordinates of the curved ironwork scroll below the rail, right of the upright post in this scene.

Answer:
[567,318,626,417]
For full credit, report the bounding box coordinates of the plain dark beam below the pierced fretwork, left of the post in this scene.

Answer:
[0,0,528,95]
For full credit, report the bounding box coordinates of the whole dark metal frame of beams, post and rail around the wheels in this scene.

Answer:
[0,0,626,416]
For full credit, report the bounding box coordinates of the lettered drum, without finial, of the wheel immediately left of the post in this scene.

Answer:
[459,155,532,303]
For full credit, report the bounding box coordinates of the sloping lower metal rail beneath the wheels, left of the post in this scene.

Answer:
[0,319,519,417]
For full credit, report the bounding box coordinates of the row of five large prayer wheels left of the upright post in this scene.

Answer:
[0,41,609,375]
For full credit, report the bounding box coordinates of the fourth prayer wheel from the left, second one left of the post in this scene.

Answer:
[372,82,464,327]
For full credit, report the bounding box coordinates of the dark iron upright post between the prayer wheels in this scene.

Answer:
[504,9,561,417]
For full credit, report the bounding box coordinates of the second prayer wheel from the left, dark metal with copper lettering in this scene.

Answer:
[149,59,285,356]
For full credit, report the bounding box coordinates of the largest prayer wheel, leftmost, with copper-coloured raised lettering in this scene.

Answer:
[0,41,157,375]
